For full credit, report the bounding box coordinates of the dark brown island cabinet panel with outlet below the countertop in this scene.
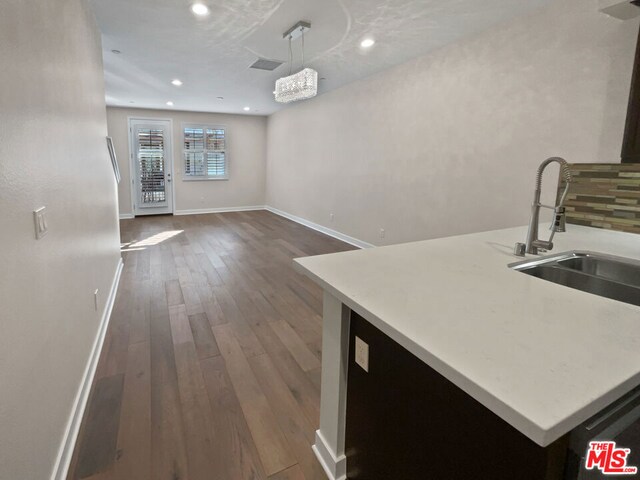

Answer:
[345,312,567,480]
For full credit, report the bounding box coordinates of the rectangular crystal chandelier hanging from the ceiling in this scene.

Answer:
[273,22,318,103]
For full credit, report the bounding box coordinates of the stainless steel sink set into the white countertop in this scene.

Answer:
[509,251,640,306]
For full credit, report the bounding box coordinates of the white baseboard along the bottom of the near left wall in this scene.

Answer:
[51,258,124,480]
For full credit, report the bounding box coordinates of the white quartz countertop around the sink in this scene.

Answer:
[295,225,640,446]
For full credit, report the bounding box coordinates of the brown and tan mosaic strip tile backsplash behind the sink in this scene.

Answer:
[562,163,640,233]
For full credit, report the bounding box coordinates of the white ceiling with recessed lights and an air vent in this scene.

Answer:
[90,0,551,115]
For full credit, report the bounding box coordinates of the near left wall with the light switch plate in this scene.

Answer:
[0,0,120,480]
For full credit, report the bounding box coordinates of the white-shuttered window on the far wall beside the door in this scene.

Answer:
[184,125,229,180]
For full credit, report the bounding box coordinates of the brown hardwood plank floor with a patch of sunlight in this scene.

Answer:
[68,211,354,480]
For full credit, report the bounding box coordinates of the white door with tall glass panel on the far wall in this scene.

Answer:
[129,119,173,215]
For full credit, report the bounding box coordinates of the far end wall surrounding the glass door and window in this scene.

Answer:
[107,107,267,215]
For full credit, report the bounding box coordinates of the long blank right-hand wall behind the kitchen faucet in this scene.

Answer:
[267,0,638,244]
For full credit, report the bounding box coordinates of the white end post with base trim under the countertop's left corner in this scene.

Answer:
[313,291,351,480]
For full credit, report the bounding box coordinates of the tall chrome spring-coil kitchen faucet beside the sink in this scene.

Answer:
[514,157,571,257]
